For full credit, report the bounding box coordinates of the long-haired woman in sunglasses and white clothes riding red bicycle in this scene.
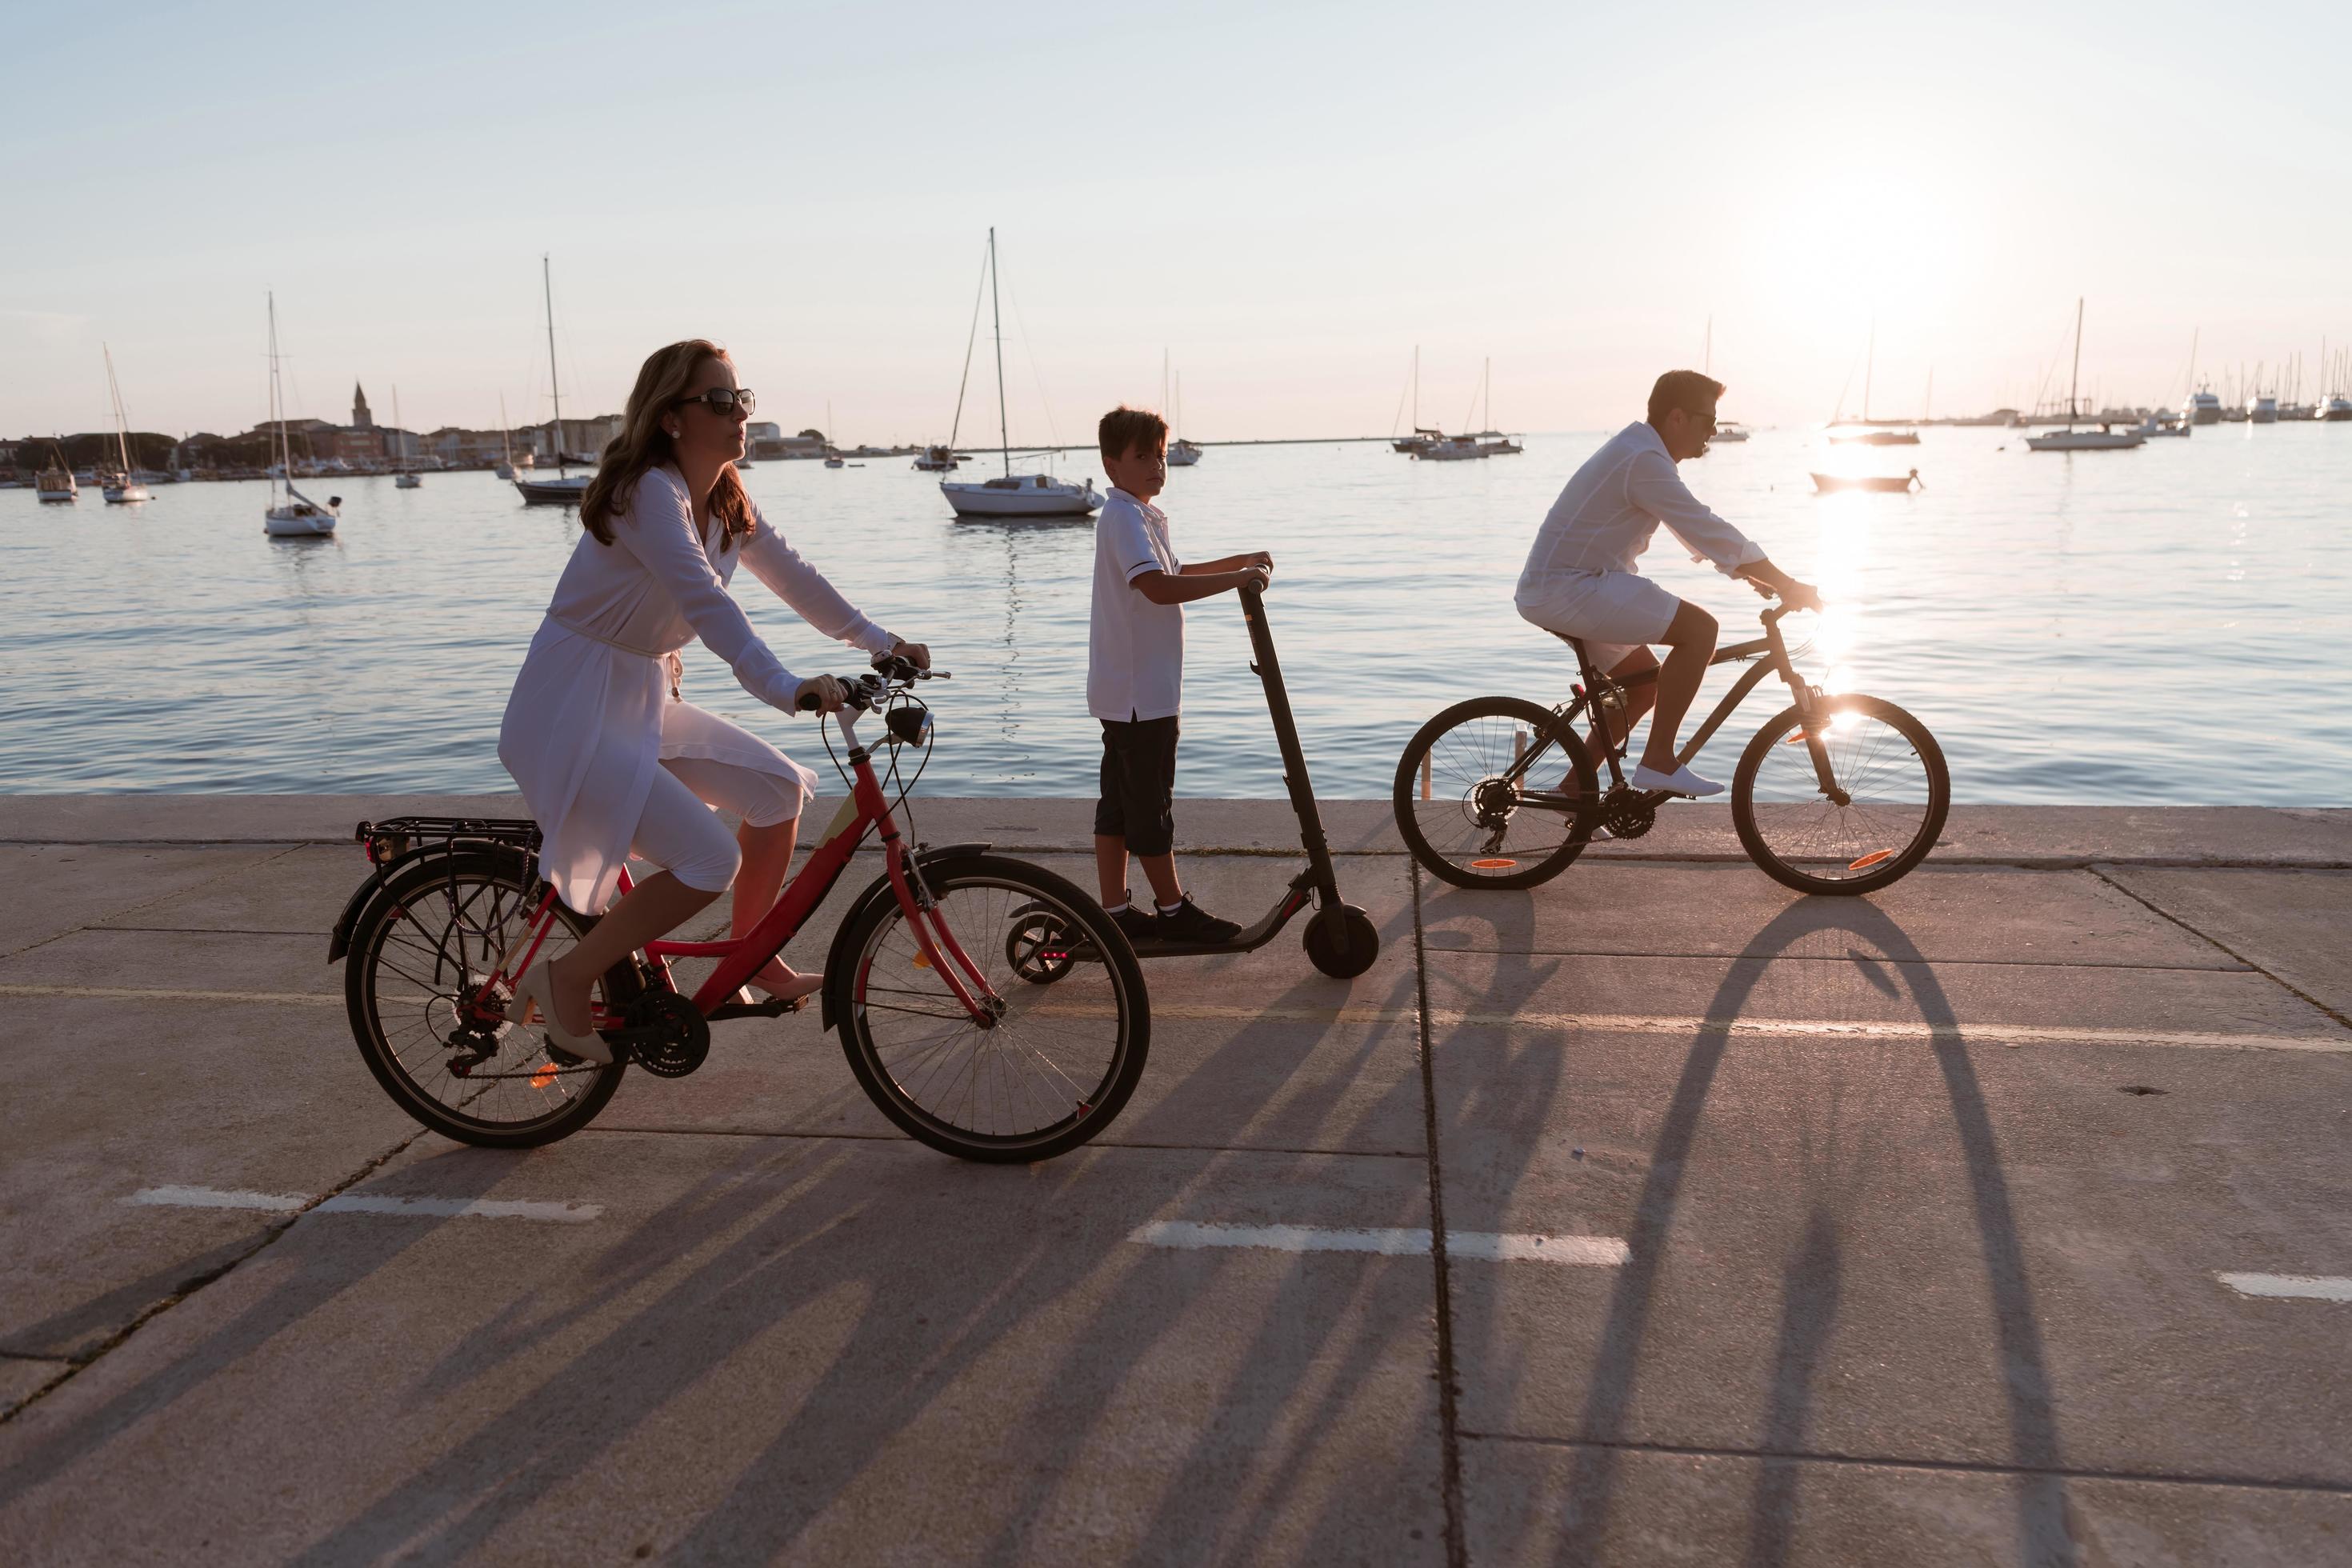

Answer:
[498,338,931,1062]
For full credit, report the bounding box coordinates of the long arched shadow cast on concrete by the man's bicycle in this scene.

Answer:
[1442,898,2079,1566]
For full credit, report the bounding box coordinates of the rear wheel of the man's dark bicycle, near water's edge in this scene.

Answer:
[1392,696,1599,889]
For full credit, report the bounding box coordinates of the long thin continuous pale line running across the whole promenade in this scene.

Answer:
[0,982,2352,1055]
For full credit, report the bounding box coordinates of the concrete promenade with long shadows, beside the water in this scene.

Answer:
[0,797,2352,1568]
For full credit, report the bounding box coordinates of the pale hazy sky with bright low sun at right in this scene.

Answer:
[0,0,2352,444]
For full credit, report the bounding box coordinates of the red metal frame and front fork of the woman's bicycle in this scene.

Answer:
[475,707,998,1030]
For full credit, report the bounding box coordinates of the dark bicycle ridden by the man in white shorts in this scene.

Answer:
[1394,604,1952,894]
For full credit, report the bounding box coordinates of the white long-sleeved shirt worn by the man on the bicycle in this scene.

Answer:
[1524,421,1764,602]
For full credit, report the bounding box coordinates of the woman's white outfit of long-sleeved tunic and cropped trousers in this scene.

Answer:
[498,468,894,912]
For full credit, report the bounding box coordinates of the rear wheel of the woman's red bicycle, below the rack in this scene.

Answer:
[343,851,640,1150]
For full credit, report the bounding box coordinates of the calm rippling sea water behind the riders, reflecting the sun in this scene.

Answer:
[0,423,2352,806]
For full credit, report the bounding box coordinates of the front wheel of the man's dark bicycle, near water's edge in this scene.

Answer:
[1731,696,1952,894]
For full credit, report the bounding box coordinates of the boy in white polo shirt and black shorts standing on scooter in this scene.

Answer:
[1086,404,1274,942]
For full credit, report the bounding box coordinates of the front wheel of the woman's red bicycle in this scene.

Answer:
[826,856,1153,1164]
